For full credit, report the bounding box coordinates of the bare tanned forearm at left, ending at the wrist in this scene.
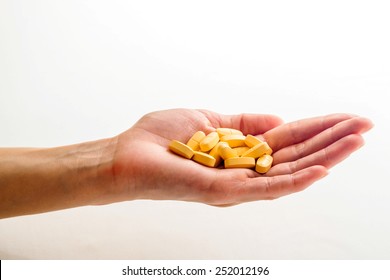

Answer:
[0,138,116,218]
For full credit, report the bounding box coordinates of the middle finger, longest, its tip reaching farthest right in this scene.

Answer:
[273,117,372,165]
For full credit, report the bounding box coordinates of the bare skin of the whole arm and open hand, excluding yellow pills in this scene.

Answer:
[0,109,372,218]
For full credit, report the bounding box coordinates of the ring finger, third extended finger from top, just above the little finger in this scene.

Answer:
[267,134,364,176]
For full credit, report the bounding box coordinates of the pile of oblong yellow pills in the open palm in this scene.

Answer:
[169,128,273,174]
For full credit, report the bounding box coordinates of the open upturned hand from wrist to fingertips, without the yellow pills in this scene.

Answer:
[109,109,372,206]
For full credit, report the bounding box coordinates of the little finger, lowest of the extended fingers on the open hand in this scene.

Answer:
[239,166,328,202]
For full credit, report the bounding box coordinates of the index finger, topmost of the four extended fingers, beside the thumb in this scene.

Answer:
[263,114,354,151]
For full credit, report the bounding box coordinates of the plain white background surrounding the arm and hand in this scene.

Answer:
[0,0,390,259]
